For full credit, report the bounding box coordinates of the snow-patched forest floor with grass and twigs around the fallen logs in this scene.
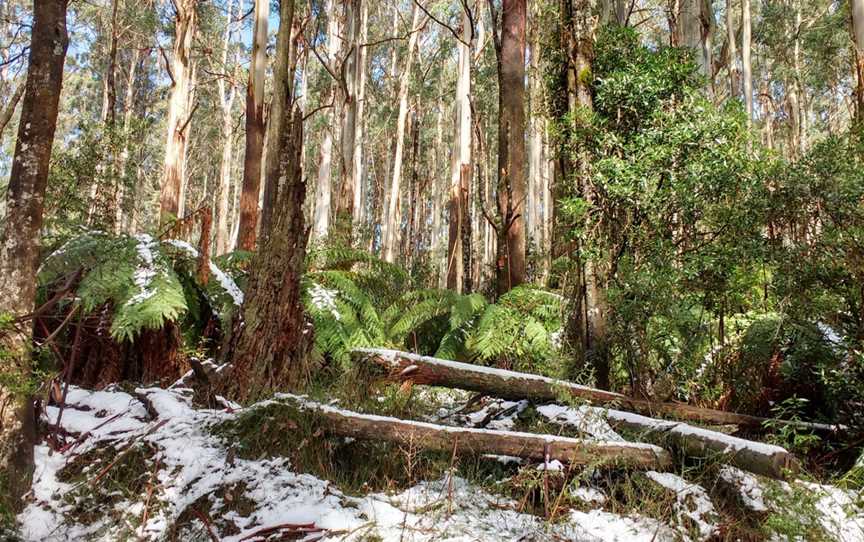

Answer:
[18,370,864,542]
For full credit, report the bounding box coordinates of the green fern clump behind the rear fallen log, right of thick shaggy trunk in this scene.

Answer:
[304,249,561,369]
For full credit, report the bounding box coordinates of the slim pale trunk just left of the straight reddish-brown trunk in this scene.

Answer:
[216,0,241,255]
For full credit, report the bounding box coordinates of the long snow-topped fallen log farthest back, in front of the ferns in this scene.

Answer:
[353,348,840,432]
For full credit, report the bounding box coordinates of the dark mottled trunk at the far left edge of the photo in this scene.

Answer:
[0,0,69,511]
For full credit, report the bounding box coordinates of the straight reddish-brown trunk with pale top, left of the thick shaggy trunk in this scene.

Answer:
[237,0,270,251]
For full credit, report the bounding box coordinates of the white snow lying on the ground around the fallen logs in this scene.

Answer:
[19,387,864,542]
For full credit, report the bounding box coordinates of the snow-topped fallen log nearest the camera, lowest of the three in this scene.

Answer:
[275,393,672,469]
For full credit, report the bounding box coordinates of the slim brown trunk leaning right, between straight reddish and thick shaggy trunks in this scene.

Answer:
[259,1,300,237]
